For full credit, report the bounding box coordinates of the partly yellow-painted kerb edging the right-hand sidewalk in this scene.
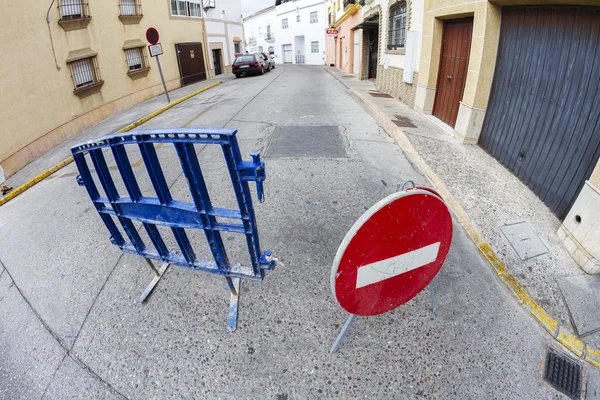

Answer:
[344,84,600,367]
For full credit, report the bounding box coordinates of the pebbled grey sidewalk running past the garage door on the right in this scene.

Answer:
[326,68,600,348]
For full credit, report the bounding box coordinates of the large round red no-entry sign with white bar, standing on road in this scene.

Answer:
[331,188,452,316]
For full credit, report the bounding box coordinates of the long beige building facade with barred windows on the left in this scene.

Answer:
[0,0,243,176]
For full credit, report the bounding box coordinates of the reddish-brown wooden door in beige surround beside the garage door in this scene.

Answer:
[433,18,473,128]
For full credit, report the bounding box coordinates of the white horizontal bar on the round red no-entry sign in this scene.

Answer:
[356,242,440,289]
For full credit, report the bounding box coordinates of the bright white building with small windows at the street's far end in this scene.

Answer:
[244,0,327,65]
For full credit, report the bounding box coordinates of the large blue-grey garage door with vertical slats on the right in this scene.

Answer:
[479,7,600,219]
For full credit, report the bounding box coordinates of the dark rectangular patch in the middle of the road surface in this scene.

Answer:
[265,125,347,157]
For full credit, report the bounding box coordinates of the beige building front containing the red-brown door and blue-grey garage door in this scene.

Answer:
[415,0,600,273]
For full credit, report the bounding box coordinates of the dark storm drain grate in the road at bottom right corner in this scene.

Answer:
[544,348,582,400]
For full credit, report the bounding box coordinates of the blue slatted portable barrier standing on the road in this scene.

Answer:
[71,129,275,331]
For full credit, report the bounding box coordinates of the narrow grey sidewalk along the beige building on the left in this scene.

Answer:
[0,74,234,192]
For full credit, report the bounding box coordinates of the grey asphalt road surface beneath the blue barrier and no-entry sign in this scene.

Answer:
[0,66,600,400]
